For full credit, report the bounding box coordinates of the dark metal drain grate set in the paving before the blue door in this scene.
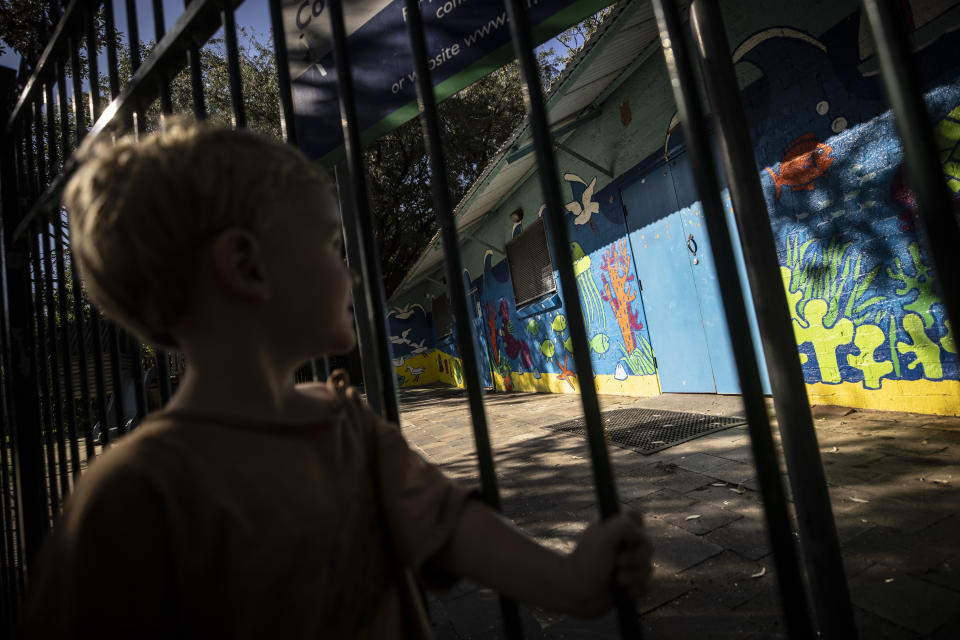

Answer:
[547,409,747,455]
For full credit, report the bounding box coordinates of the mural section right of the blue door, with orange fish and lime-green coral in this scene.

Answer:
[748,7,960,413]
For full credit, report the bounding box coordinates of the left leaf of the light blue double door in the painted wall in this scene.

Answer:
[621,165,717,393]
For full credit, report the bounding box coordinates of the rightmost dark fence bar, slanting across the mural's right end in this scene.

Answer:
[863,0,960,336]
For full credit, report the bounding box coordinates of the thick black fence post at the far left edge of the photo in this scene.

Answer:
[0,123,48,568]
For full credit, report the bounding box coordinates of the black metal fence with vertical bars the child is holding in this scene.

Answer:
[0,0,960,639]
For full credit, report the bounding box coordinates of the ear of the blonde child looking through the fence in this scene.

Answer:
[212,227,270,301]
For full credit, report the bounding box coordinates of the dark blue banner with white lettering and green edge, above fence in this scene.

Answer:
[284,0,610,164]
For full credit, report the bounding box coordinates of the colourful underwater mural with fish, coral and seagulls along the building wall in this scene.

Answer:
[390,3,960,415]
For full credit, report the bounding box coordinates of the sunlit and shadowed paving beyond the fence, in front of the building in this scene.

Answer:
[401,388,960,640]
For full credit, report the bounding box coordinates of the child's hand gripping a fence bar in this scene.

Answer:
[566,511,653,617]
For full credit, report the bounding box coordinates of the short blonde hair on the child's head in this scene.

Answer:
[63,121,331,347]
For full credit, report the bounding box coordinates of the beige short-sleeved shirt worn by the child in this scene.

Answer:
[23,394,467,639]
